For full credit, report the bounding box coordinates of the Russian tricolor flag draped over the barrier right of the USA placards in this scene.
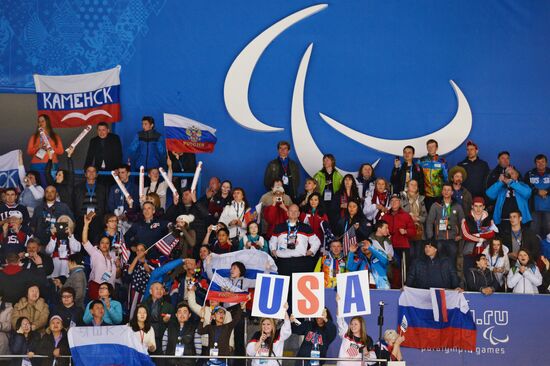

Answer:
[398,287,476,351]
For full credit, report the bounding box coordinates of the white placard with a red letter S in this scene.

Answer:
[292,272,325,318]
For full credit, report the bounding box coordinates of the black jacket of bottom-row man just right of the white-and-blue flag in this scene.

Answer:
[164,320,198,366]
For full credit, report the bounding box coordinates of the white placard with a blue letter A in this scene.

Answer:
[336,271,370,317]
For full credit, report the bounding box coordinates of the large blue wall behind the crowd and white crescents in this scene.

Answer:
[0,0,550,200]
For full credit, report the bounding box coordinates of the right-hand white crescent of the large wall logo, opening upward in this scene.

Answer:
[319,80,472,156]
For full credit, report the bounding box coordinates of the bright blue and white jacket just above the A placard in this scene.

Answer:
[348,244,390,289]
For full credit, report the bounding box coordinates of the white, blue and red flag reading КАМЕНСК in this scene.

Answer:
[34,66,121,127]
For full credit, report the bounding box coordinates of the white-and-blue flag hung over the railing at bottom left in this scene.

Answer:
[68,325,154,366]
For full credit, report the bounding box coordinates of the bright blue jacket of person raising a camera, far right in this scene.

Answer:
[485,181,532,225]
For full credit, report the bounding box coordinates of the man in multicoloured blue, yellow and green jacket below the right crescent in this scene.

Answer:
[418,139,447,211]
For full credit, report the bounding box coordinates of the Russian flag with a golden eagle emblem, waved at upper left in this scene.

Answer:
[164,113,217,153]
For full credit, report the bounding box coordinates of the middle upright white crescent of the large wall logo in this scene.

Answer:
[290,43,380,177]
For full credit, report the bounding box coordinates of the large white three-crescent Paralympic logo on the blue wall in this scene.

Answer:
[224,4,472,175]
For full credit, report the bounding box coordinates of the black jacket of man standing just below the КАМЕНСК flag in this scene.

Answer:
[84,133,122,171]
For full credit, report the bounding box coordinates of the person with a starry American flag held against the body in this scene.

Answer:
[126,244,154,318]
